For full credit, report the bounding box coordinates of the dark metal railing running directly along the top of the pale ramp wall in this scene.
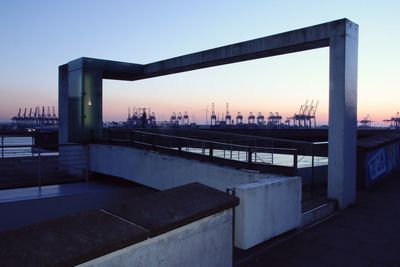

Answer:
[97,130,297,175]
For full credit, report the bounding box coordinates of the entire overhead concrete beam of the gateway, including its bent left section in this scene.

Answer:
[68,19,352,81]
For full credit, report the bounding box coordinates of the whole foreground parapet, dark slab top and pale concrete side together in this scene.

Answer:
[0,183,238,266]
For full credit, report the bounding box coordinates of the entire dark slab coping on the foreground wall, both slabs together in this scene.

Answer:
[0,183,239,266]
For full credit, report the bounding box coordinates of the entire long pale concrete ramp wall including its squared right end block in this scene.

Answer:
[89,145,302,249]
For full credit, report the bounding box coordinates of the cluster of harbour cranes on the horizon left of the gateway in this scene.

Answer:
[11,106,58,128]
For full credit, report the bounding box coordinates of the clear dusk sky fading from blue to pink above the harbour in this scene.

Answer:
[0,0,400,125]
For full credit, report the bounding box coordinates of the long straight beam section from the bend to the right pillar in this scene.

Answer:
[134,19,352,80]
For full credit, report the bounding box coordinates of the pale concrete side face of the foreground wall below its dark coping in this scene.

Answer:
[79,209,232,267]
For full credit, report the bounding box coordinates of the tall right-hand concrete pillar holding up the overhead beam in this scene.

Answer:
[328,21,358,208]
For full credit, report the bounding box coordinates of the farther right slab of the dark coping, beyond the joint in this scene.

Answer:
[107,183,239,236]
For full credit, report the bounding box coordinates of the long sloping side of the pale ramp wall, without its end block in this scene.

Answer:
[89,145,277,192]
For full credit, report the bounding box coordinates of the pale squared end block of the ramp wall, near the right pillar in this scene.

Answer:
[233,177,302,249]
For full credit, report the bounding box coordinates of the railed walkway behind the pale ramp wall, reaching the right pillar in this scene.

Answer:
[101,129,328,194]
